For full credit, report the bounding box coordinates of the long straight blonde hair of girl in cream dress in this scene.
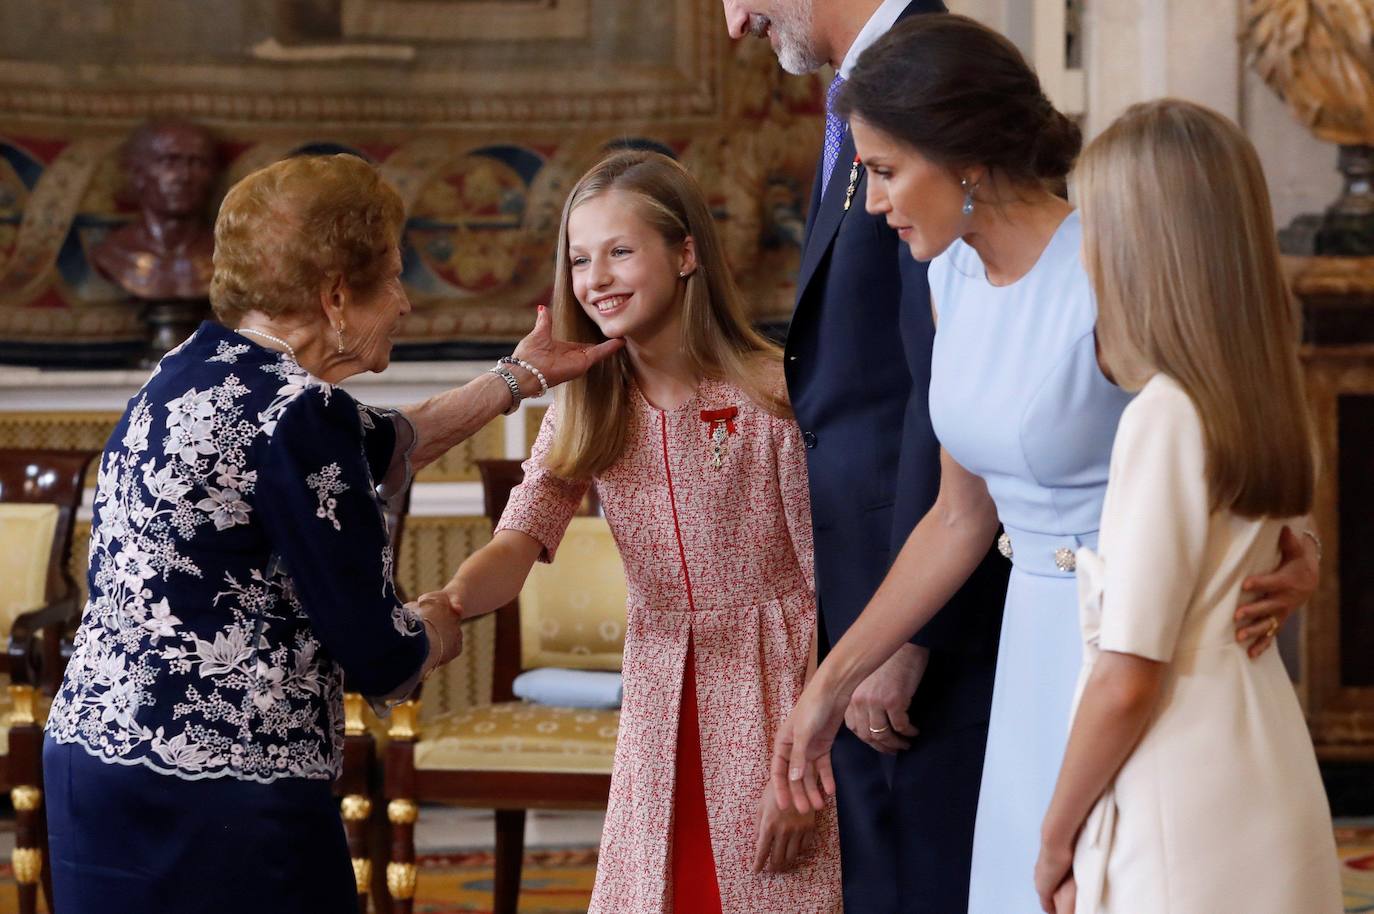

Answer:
[1074,99,1316,517]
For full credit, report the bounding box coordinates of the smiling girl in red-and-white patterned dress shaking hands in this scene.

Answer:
[425,151,840,914]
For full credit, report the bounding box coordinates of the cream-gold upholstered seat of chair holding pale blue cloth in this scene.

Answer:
[415,701,620,775]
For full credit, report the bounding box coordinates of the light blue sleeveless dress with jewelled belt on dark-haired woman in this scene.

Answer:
[930,213,1129,914]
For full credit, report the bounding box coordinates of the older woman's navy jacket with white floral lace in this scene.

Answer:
[47,317,427,782]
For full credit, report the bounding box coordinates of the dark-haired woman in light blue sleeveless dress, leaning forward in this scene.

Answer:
[774,15,1311,914]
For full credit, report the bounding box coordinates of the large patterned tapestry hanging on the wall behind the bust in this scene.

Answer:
[0,0,823,361]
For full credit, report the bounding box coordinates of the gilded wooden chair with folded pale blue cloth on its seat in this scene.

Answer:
[386,460,625,914]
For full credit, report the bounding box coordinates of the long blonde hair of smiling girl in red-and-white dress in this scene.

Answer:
[545,150,791,478]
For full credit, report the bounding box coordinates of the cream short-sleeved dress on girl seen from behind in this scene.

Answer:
[1073,375,1344,914]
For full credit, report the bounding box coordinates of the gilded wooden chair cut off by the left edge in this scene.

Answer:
[0,449,96,914]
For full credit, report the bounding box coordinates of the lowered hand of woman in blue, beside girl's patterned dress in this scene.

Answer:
[772,673,849,812]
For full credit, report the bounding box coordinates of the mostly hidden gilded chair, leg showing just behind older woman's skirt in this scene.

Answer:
[334,487,411,914]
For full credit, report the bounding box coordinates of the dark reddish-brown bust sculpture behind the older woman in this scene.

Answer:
[92,121,216,301]
